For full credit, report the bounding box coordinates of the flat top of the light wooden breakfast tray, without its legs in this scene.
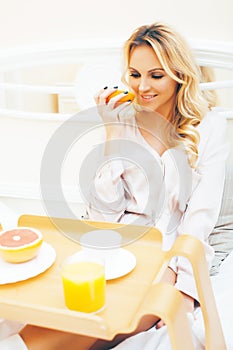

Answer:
[0,215,165,339]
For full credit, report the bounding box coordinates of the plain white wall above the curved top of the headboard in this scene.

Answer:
[0,0,233,49]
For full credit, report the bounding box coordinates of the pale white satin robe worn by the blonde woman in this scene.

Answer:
[87,112,228,300]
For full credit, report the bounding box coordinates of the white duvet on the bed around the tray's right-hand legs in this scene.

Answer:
[114,251,233,350]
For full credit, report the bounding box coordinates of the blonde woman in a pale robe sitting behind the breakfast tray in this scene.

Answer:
[0,23,227,350]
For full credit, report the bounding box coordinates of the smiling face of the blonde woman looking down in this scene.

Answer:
[129,46,177,119]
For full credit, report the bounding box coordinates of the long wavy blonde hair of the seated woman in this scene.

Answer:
[122,23,208,167]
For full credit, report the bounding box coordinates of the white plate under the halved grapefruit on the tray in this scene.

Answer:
[0,242,56,284]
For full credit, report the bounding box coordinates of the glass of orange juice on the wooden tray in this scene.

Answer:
[62,261,105,312]
